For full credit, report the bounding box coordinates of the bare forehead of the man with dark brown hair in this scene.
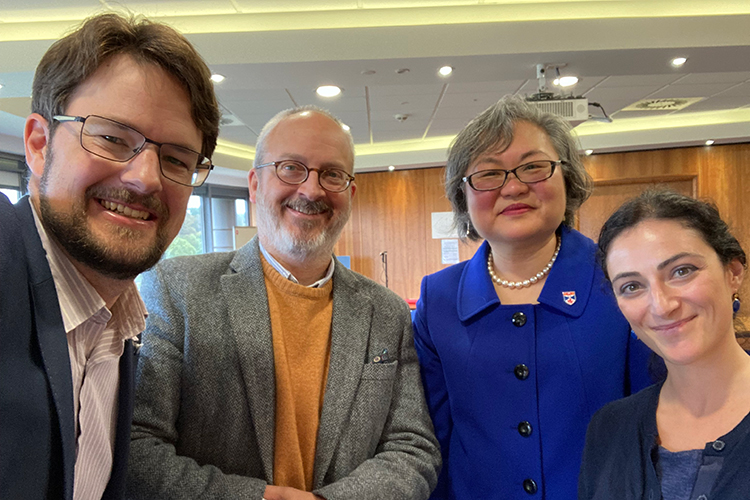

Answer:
[65,54,202,151]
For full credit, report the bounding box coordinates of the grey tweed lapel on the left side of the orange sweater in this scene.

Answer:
[221,238,276,482]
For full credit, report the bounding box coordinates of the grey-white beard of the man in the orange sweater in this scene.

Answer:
[255,189,351,259]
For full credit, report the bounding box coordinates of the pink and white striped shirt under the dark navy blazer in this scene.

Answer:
[32,206,147,500]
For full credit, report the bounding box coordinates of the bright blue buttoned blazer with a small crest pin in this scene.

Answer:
[414,227,650,500]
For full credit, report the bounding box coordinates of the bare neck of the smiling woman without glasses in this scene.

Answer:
[661,335,750,417]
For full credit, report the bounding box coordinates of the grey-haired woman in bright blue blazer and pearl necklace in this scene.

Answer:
[414,97,648,500]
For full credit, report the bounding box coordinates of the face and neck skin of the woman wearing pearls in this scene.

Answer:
[465,122,566,304]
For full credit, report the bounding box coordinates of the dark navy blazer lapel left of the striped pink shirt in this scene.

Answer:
[16,197,76,498]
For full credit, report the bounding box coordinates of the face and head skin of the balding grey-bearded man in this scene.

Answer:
[248,112,357,285]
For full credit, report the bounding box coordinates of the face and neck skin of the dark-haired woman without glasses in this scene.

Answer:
[607,219,750,451]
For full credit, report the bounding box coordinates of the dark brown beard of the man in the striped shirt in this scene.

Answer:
[39,149,172,280]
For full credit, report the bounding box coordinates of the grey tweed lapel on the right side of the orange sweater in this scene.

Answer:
[313,262,372,488]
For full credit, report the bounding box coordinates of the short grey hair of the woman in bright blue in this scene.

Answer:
[445,95,594,241]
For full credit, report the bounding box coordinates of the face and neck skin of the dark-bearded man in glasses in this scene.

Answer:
[24,55,202,306]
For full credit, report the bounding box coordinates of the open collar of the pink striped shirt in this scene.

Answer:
[30,203,148,340]
